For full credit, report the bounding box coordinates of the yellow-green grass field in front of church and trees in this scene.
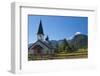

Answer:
[28,49,88,61]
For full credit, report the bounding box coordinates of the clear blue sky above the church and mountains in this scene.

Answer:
[28,15,88,43]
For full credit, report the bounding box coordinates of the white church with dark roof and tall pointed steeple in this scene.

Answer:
[28,20,54,55]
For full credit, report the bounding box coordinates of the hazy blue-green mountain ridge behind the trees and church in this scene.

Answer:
[28,34,88,49]
